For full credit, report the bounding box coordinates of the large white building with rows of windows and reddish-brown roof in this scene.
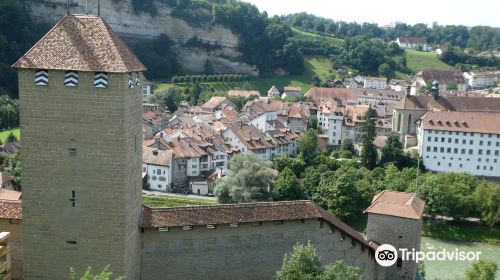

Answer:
[417,111,500,177]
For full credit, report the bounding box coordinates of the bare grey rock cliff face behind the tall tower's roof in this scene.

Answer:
[23,0,258,76]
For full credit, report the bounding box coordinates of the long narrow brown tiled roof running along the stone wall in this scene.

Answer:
[140,200,373,249]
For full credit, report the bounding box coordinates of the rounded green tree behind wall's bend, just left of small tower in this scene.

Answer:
[315,166,360,221]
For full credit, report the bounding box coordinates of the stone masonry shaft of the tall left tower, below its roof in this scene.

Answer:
[19,70,141,280]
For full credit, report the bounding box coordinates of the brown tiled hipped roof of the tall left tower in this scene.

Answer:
[13,15,145,73]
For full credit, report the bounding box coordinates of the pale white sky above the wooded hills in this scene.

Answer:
[243,0,500,27]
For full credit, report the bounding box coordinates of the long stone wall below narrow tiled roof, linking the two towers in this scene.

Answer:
[141,219,376,280]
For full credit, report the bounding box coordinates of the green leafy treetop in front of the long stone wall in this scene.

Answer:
[274,242,321,280]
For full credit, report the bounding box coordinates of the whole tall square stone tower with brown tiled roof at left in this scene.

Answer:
[13,15,145,280]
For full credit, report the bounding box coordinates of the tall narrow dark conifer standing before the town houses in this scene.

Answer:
[361,105,378,170]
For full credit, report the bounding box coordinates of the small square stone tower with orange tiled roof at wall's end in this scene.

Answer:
[365,191,425,280]
